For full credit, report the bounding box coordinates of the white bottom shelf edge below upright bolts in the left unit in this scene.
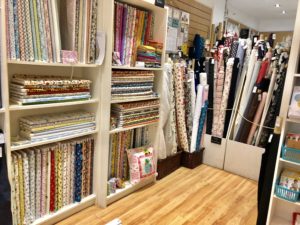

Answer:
[32,194,96,225]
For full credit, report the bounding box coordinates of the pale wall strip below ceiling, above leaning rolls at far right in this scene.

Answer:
[258,19,295,32]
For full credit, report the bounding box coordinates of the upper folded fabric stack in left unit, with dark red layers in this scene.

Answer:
[10,75,91,105]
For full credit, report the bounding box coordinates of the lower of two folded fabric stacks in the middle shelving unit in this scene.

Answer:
[112,100,159,128]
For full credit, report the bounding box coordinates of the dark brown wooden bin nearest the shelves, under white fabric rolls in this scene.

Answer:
[157,151,182,180]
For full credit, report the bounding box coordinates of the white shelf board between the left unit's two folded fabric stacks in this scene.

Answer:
[9,99,99,111]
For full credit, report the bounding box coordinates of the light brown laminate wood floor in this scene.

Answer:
[59,165,257,225]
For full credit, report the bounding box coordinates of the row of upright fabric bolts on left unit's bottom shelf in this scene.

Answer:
[12,137,94,224]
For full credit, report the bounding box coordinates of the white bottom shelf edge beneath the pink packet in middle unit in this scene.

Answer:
[106,175,156,205]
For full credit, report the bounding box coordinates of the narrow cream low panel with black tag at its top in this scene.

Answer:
[203,134,226,169]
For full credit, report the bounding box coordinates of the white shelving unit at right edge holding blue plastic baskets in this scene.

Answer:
[267,1,300,225]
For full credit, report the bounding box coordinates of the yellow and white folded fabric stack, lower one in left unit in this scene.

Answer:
[19,111,96,142]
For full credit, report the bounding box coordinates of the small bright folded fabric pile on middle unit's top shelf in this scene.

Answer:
[137,45,161,68]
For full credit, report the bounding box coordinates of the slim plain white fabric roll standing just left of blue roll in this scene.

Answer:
[190,84,204,152]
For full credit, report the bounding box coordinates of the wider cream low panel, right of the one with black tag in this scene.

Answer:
[224,140,265,181]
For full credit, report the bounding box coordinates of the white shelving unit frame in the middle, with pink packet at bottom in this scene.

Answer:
[97,0,167,207]
